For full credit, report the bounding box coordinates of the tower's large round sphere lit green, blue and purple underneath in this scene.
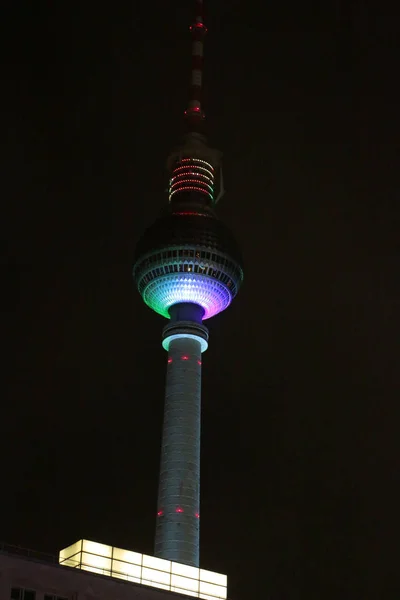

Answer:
[133,204,243,319]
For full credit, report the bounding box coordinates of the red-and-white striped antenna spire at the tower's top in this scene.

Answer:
[185,0,207,131]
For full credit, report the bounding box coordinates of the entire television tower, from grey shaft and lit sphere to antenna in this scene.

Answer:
[133,0,243,567]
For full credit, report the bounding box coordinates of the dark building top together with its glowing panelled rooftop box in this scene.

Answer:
[0,540,227,600]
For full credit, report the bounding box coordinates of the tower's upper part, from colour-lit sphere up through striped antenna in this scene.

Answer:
[133,0,243,319]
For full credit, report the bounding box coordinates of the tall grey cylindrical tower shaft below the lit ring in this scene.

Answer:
[155,333,201,567]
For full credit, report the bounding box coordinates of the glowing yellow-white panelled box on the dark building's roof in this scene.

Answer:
[59,540,227,600]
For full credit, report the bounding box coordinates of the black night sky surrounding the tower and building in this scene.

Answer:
[0,0,400,600]
